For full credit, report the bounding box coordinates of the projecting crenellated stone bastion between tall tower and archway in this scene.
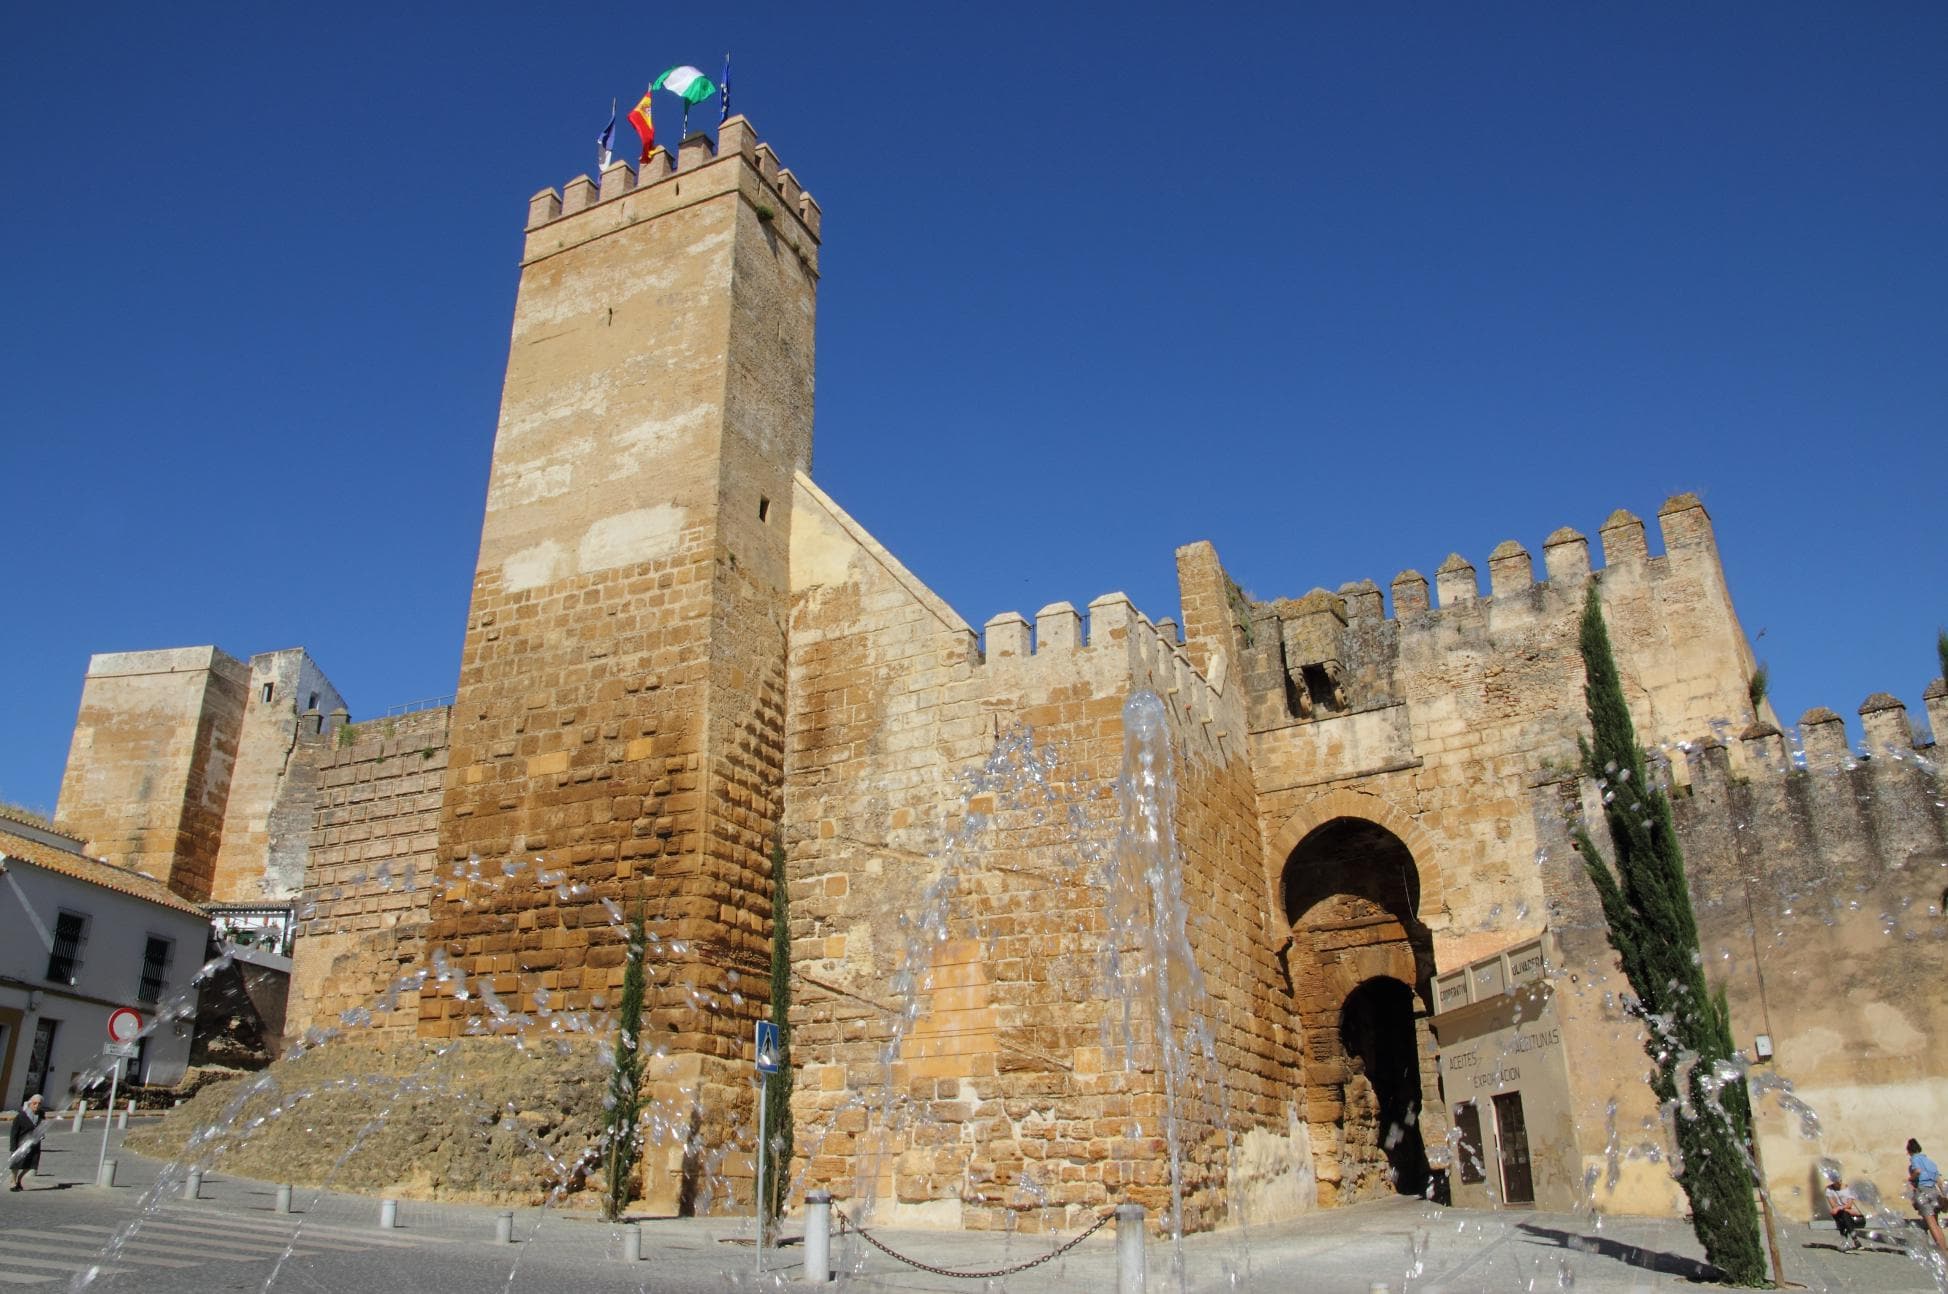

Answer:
[787,481,1311,1230]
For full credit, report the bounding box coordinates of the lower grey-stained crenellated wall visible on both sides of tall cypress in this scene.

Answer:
[1535,688,1948,1220]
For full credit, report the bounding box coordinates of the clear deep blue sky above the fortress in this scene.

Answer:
[0,2,1948,811]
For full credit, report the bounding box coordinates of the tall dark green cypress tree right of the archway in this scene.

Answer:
[1574,585,1767,1286]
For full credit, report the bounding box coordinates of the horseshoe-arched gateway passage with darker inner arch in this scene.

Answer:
[1282,817,1447,1204]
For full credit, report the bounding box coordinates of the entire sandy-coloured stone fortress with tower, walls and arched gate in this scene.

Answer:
[58,117,1948,1230]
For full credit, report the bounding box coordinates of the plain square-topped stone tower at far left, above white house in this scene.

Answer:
[55,647,249,900]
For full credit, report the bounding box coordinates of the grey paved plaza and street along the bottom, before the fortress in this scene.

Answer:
[0,1121,1944,1294]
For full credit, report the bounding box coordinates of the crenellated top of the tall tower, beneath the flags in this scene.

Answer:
[524,117,822,261]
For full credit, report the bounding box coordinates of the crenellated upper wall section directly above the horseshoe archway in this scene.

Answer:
[1179,493,1784,780]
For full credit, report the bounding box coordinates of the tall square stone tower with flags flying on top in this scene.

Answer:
[421,117,818,1199]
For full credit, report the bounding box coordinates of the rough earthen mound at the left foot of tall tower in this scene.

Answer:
[127,1039,608,1202]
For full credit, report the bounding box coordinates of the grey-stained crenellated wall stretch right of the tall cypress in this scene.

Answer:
[1675,696,1948,1218]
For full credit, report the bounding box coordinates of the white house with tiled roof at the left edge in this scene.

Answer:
[0,815,210,1109]
